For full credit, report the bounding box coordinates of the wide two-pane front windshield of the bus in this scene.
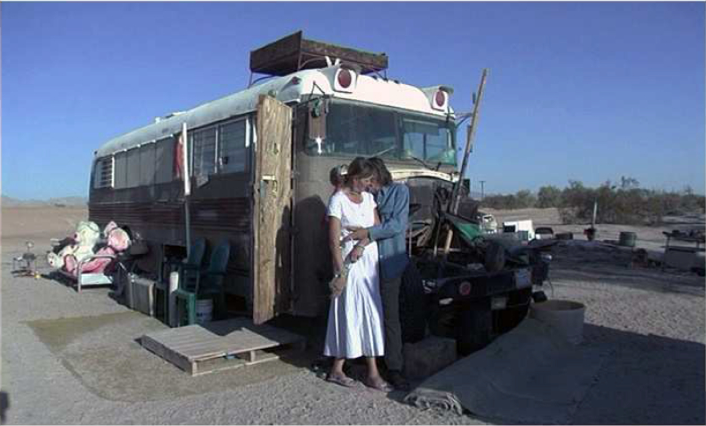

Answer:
[306,100,456,168]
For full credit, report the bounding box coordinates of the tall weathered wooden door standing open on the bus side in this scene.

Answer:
[253,95,292,324]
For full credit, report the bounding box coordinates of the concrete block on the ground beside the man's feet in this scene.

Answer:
[403,336,457,380]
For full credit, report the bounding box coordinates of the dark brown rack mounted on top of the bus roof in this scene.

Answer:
[250,31,387,76]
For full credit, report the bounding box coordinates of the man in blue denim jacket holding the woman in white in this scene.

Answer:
[340,157,409,390]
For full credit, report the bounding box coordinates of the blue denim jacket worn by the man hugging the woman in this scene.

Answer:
[368,183,409,280]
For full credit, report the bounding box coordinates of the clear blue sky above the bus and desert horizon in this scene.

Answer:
[1,2,706,198]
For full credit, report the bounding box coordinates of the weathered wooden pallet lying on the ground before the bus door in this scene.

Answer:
[140,318,306,376]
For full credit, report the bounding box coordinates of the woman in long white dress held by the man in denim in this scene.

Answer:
[324,157,392,391]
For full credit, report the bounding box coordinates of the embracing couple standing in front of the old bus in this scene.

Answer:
[324,157,409,392]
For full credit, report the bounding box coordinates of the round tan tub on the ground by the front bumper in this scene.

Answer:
[530,300,586,345]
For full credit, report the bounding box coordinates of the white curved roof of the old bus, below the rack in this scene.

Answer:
[96,65,453,158]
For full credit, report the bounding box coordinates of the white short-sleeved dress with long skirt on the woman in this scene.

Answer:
[324,191,385,358]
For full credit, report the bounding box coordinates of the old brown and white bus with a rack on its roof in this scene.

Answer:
[89,32,458,323]
